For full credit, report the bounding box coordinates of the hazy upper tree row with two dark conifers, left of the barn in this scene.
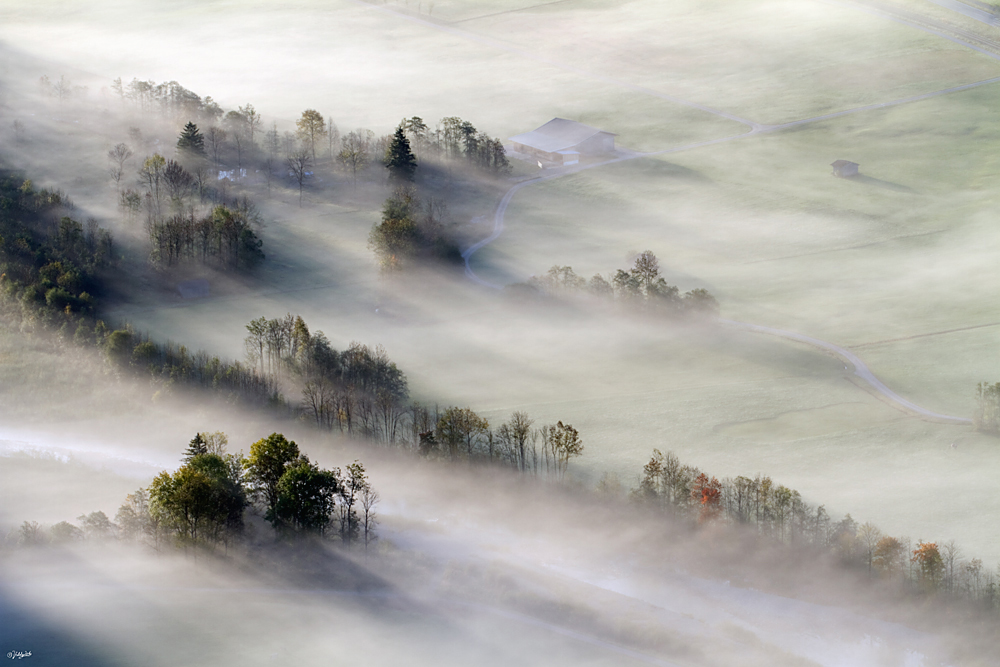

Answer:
[109,78,511,207]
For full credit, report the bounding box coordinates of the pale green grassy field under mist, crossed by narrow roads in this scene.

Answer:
[0,0,1000,560]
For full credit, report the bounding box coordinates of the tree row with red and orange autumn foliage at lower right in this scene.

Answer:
[632,450,1000,609]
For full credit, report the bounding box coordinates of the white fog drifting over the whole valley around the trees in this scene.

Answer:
[0,0,1000,665]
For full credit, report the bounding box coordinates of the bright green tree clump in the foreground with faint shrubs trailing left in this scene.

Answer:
[7,432,379,550]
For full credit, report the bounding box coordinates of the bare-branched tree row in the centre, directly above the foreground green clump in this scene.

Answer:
[244,314,583,477]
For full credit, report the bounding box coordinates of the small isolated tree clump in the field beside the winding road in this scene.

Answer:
[507,250,719,315]
